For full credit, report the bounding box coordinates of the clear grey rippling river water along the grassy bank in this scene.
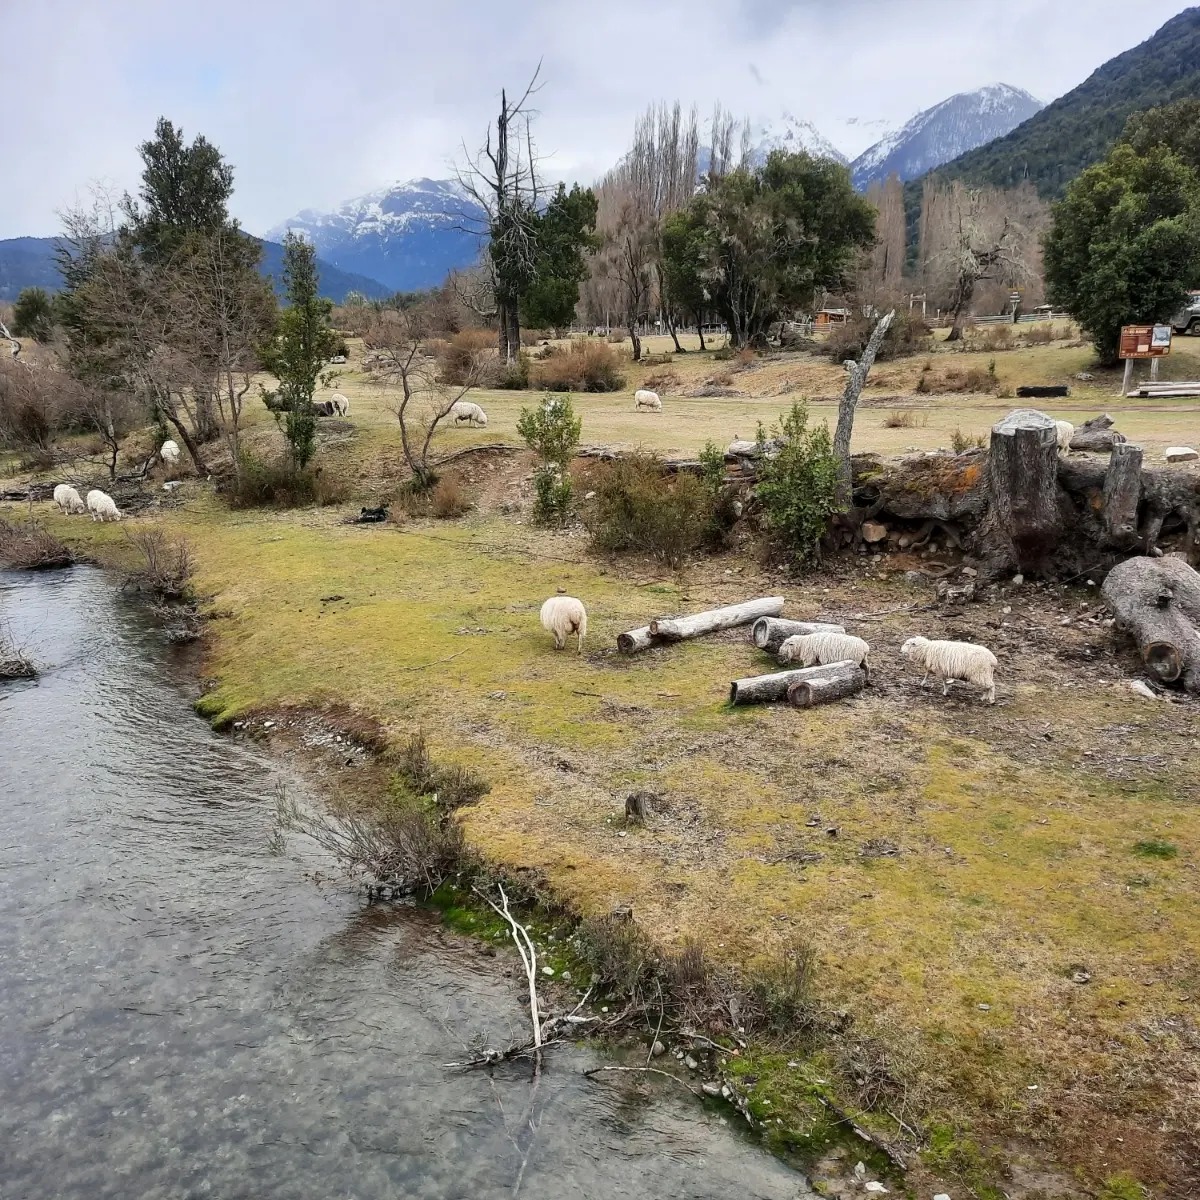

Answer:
[0,568,808,1200]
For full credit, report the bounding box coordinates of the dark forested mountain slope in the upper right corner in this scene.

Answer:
[937,5,1200,198]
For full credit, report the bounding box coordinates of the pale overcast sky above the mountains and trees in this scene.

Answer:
[0,0,1189,238]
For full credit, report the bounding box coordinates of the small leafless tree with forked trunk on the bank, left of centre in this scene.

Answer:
[364,308,481,488]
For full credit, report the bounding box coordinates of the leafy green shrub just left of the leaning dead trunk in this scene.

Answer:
[755,402,839,568]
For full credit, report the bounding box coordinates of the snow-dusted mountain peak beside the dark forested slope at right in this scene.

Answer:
[851,83,1044,190]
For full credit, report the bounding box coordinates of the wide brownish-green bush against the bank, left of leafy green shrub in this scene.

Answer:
[588,451,732,566]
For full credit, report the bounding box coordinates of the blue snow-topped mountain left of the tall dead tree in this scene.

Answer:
[268,179,482,292]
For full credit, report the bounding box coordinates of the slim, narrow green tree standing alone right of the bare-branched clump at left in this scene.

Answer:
[263,233,337,470]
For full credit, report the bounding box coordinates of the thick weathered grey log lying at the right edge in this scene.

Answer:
[1102,557,1200,692]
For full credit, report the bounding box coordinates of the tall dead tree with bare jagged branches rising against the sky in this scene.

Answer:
[458,64,541,364]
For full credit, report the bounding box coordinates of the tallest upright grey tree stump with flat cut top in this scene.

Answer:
[985,408,1062,574]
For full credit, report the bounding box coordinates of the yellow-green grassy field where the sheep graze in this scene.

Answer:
[0,328,1200,1200]
